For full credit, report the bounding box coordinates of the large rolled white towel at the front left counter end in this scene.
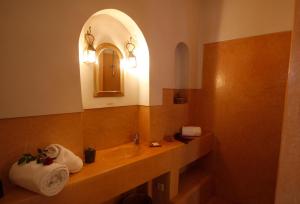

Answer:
[9,161,69,196]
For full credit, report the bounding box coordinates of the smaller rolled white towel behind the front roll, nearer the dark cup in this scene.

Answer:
[45,144,83,173]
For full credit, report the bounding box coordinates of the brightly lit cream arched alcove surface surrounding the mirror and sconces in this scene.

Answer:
[79,9,149,109]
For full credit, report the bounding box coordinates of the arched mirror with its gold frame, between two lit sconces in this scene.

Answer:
[94,43,124,97]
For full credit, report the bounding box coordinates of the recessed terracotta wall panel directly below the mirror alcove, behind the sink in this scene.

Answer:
[82,106,139,149]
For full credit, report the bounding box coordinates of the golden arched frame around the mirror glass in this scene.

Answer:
[94,43,124,97]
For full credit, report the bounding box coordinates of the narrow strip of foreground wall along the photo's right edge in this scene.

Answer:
[276,0,300,204]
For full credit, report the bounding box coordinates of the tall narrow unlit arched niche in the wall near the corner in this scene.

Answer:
[174,42,189,104]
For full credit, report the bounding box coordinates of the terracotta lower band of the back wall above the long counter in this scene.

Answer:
[0,89,189,191]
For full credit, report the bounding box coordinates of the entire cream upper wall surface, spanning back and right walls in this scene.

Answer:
[0,0,294,118]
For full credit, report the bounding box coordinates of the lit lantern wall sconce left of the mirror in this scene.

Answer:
[83,26,96,63]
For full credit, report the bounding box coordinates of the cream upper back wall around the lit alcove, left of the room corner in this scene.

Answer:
[0,0,198,118]
